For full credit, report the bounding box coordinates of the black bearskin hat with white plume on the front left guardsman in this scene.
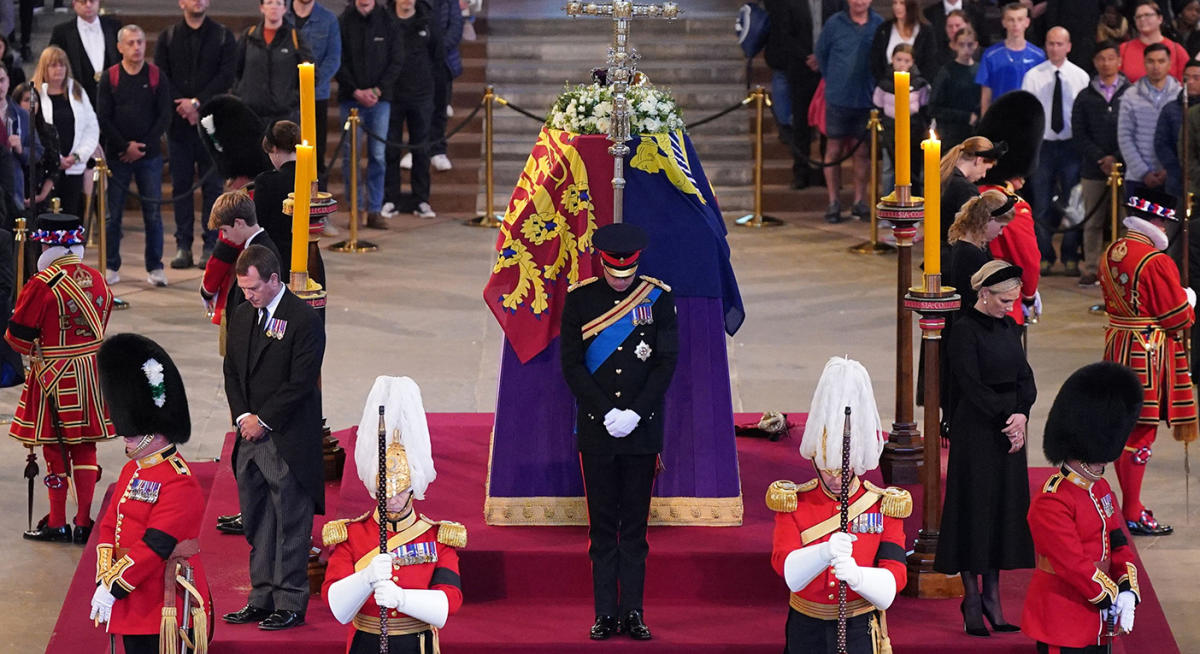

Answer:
[96,334,192,443]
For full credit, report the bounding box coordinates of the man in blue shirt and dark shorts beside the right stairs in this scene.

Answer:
[816,0,883,223]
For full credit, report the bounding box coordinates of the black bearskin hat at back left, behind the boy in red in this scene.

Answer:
[196,95,274,179]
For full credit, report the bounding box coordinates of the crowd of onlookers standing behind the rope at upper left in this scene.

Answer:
[0,0,478,287]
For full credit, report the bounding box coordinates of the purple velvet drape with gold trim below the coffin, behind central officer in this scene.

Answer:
[490,298,740,497]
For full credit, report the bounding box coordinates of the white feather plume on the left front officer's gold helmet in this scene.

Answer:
[354,376,437,499]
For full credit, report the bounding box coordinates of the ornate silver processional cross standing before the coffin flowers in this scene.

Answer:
[564,0,683,223]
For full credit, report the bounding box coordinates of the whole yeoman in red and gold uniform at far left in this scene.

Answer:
[5,214,113,545]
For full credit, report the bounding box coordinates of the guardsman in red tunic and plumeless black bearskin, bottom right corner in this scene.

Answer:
[1021,361,1142,654]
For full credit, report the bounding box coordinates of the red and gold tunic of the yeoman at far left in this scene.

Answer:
[5,254,113,445]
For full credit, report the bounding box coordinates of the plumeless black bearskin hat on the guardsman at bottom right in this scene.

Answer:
[1042,361,1142,463]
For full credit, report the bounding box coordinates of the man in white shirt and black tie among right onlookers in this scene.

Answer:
[1021,28,1090,277]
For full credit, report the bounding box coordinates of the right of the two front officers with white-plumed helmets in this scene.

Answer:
[767,356,912,654]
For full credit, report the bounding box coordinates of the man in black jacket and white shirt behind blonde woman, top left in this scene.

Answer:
[50,0,121,108]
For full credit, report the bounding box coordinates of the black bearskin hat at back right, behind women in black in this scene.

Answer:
[976,91,1046,185]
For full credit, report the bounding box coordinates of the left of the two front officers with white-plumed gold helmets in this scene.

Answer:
[322,377,467,654]
